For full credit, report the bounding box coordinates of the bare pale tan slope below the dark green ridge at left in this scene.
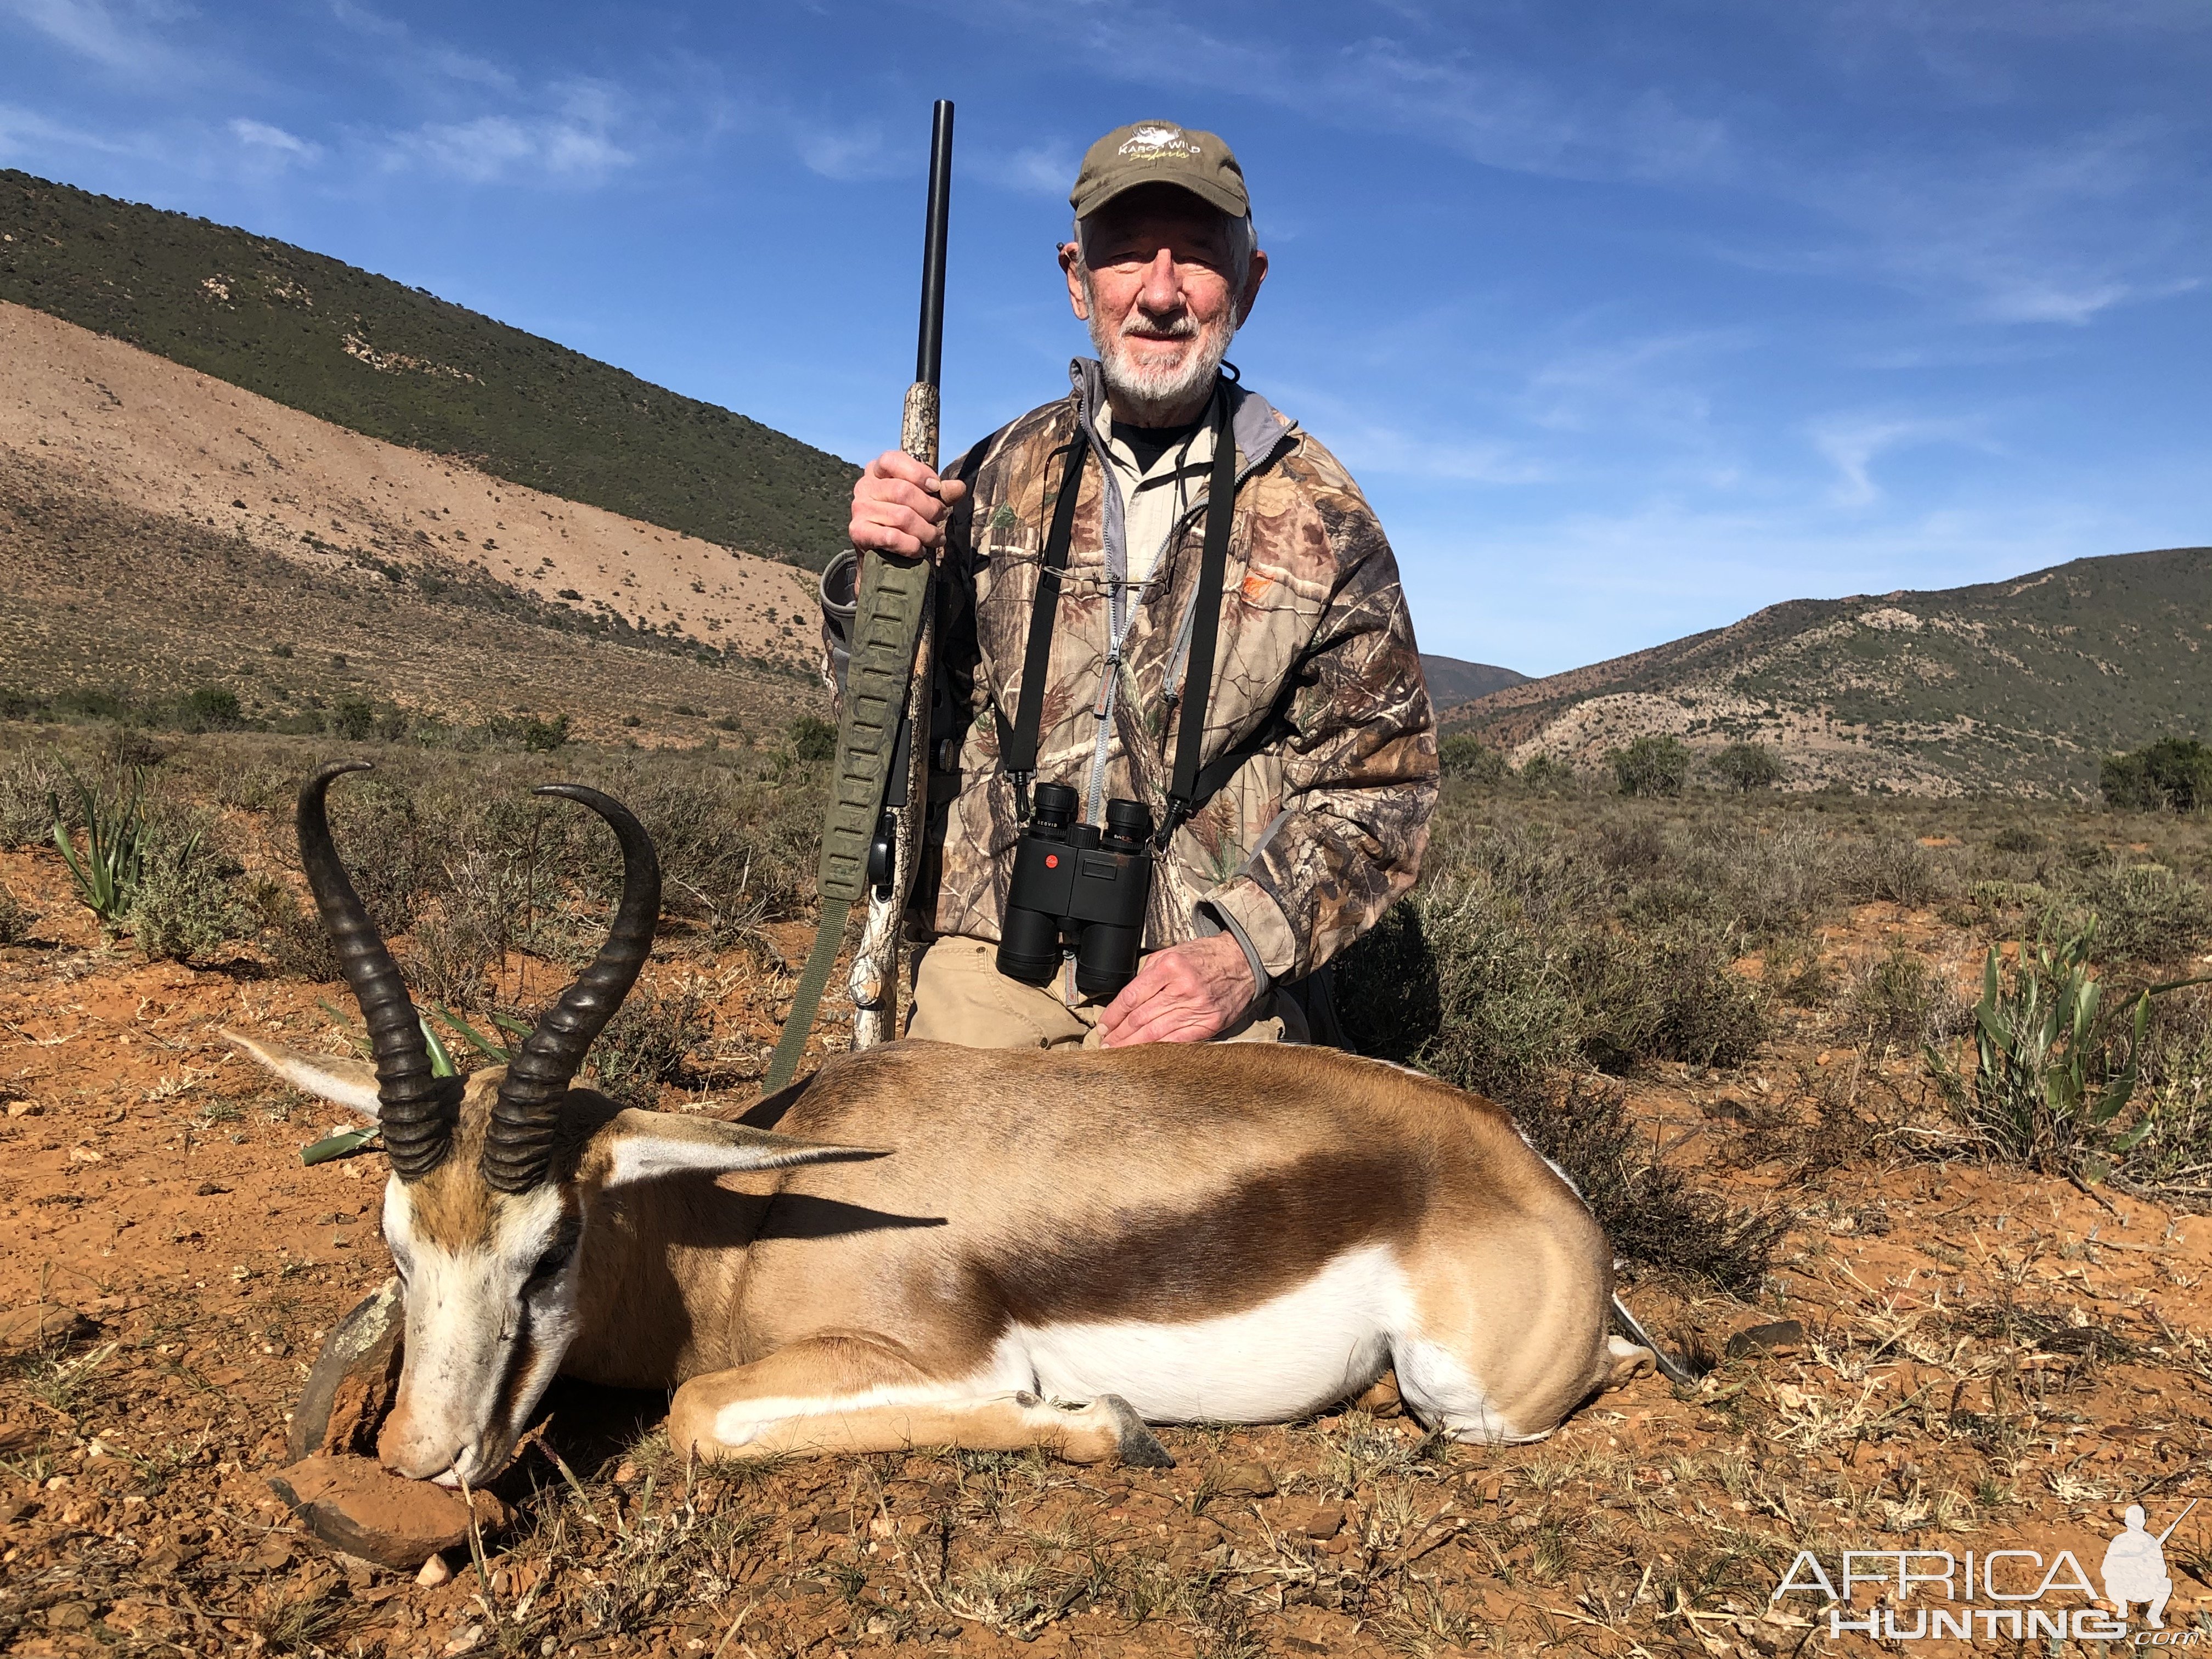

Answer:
[0,303,823,743]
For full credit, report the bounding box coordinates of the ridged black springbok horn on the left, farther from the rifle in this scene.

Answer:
[298,761,460,1181]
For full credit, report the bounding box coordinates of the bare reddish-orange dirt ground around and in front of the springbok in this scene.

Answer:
[0,854,2212,1659]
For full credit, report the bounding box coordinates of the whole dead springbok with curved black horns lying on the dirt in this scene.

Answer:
[228,761,1655,1484]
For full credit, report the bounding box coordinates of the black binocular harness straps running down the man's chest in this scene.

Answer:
[997,396,1254,851]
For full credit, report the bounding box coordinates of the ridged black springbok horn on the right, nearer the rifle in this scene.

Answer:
[484,783,662,1192]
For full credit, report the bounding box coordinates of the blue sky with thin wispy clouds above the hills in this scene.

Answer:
[0,0,2212,673]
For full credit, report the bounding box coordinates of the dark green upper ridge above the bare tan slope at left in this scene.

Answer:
[0,170,856,568]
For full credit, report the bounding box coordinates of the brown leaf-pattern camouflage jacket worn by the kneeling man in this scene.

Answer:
[825,360,1438,989]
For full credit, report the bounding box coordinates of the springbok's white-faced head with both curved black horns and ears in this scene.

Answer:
[225,761,876,1484]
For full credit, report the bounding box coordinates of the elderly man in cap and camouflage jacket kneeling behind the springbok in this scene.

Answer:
[823,122,1436,1046]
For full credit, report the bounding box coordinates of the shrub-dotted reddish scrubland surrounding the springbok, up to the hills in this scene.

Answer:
[0,721,2212,1659]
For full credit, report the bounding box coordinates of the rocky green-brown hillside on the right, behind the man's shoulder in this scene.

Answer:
[1444,546,2212,794]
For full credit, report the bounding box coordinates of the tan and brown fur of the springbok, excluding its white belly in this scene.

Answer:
[238,1042,1648,1460]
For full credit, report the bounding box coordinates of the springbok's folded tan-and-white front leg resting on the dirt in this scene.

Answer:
[668,1336,1175,1469]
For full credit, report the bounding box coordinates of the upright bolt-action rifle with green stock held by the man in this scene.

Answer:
[761,97,953,1095]
